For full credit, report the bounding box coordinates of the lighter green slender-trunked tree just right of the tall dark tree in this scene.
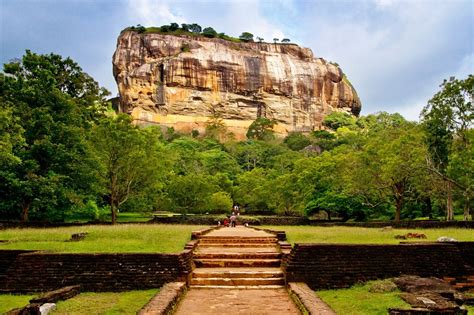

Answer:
[90,114,160,224]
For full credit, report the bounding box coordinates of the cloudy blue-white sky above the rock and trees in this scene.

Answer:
[0,0,474,120]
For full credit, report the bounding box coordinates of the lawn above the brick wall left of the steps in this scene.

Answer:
[0,224,203,253]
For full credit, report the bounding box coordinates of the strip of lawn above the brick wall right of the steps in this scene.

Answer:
[265,226,474,244]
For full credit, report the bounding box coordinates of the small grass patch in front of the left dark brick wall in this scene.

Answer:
[51,289,158,315]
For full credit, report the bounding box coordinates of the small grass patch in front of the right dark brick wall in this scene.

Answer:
[317,281,410,315]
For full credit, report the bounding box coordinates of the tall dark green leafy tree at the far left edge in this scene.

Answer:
[0,51,108,221]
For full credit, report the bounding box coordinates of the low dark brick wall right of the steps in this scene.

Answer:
[284,243,474,290]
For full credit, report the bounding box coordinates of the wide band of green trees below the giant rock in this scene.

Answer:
[0,51,474,222]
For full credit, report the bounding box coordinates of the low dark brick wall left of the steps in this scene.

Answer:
[0,250,192,292]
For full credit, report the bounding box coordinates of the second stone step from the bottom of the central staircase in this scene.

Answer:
[193,268,283,278]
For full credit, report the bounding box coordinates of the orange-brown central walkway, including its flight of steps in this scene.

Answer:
[175,226,300,315]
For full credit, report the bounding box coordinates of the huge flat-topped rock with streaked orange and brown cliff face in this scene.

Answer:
[113,31,361,139]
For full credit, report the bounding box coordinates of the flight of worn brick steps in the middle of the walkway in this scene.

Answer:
[190,232,285,289]
